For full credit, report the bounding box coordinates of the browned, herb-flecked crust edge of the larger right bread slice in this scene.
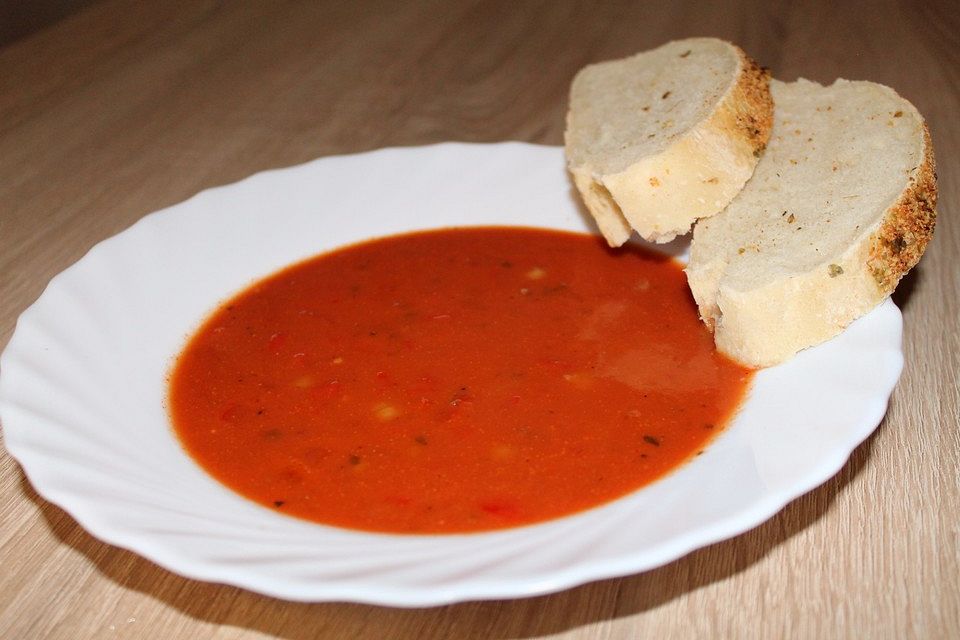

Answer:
[867,123,937,296]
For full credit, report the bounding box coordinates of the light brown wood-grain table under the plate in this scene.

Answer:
[0,0,960,640]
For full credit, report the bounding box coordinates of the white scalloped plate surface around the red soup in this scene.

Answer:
[0,143,902,606]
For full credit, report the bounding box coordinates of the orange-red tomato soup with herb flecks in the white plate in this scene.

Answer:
[169,228,752,533]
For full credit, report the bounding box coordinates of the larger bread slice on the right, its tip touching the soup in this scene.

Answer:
[686,80,937,367]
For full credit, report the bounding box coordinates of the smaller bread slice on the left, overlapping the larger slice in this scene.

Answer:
[565,38,773,246]
